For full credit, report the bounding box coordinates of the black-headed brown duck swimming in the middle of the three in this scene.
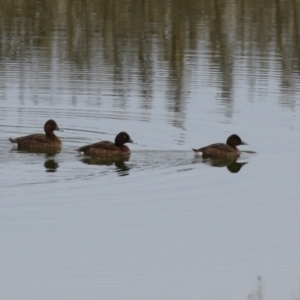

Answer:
[76,131,133,157]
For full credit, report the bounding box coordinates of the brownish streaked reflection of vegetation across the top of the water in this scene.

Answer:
[0,0,300,115]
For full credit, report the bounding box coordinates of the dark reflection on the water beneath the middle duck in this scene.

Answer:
[82,156,131,176]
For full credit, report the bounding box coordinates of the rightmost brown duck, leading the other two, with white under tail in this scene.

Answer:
[192,134,248,158]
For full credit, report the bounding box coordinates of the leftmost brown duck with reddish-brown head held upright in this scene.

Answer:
[9,119,63,150]
